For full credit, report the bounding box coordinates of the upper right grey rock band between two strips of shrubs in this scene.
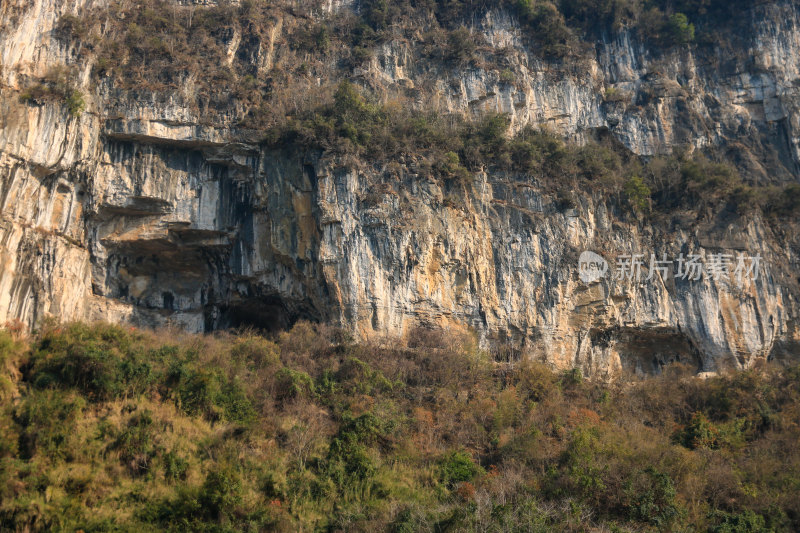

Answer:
[361,2,800,181]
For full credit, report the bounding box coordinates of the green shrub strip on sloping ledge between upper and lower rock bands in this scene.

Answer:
[265,81,800,217]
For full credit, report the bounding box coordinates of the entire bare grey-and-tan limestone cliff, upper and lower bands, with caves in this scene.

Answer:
[0,0,800,376]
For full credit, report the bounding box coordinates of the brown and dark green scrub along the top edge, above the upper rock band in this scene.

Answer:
[50,0,764,111]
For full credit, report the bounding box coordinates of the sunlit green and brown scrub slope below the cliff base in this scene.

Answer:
[0,323,800,532]
